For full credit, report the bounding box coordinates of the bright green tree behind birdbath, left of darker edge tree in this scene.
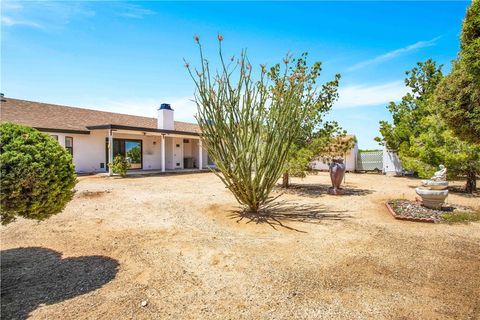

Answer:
[376,59,480,192]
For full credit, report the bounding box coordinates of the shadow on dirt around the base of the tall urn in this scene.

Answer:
[277,183,374,197]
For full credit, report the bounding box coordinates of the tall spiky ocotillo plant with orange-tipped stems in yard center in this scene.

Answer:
[185,36,330,212]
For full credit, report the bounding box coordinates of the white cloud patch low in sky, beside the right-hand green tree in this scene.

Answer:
[334,81,408,109]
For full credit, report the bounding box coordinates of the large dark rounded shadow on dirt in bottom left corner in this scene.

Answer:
[1,247,119,319]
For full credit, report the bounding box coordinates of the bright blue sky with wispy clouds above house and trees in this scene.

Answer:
[1,0,469,148]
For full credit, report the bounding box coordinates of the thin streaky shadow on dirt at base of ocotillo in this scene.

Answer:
[229,201,352,233]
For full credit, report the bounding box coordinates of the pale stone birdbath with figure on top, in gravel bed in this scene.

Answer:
[415,165,448,209]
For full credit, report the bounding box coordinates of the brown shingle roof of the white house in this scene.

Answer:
[0,97,200,133]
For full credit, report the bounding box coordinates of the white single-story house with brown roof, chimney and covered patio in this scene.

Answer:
[0,96,213,174]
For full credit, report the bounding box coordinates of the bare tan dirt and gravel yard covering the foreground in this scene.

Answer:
[1,173,480,319]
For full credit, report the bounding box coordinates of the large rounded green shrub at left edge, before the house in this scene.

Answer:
[0,123,77,225]
